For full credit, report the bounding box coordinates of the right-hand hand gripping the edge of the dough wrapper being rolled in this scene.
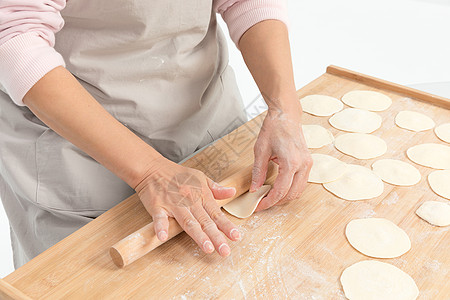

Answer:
[250,95,312,211]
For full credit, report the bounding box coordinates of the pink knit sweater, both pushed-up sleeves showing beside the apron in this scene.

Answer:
[0,0,287,106]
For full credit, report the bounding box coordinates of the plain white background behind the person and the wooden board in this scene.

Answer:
[0,0,450,277]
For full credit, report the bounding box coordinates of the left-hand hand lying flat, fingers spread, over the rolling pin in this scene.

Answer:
[135,158,240,256]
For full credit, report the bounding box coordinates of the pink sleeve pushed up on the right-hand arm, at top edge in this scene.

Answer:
[214,0,289,48]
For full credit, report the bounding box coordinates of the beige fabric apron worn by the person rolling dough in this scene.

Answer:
[0,0,246,267]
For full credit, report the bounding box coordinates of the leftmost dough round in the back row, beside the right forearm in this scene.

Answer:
[300,95,344,117]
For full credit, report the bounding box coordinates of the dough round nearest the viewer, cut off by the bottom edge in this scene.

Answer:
[341,260,419,300]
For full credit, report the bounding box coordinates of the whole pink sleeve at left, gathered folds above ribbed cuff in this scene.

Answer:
[0,0,66,106]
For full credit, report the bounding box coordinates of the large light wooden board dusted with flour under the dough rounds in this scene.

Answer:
[0,66,450,299]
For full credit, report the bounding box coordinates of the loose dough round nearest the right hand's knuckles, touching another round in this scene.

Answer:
[308,153,347,183]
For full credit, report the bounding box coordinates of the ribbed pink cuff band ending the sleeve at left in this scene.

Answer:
[0,32,65,106]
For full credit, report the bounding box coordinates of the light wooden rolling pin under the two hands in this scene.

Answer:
[109,162,278,268]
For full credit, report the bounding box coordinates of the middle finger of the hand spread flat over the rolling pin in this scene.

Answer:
[191,200,231,256]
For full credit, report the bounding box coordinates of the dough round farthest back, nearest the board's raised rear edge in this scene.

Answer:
[342,91,392,111]
